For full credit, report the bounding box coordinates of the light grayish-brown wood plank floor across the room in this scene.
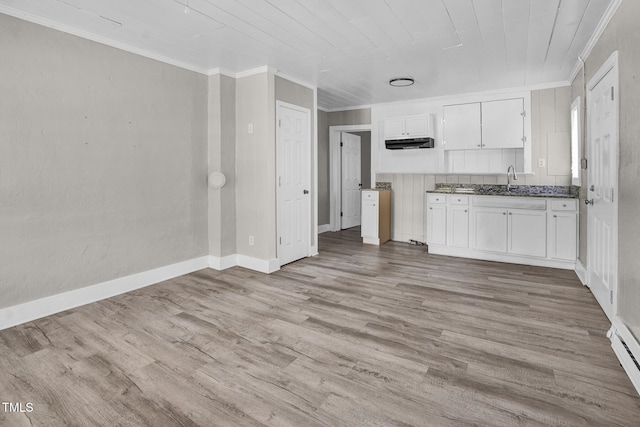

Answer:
[0,228,640,427]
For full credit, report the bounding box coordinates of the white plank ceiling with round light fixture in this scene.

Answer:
[0,0,614,109]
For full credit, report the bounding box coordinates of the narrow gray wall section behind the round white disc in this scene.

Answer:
[208,74,236,258]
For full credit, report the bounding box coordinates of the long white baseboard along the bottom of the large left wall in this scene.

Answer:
[0,257,209,330]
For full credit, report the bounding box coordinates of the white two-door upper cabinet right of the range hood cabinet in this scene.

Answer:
[443,98,525,150]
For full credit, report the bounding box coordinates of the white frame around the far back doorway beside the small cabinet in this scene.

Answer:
[329,124,373,231]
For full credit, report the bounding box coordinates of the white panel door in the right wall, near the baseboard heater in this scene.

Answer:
[587,53,618,319]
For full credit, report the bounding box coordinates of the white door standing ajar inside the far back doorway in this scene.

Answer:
[340,132,362,230]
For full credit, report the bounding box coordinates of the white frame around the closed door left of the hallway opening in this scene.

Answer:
[274,100,318,266]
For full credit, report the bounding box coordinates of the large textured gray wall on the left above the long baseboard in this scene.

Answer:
[0,14,207,308]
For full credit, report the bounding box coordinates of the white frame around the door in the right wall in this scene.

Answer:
[583,50,620,322]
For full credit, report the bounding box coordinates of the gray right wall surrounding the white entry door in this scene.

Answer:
[572,1,640,340]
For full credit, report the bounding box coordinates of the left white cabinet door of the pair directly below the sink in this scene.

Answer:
[472,208,507,252]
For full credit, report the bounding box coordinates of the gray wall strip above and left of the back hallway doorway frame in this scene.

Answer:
[318,108,371,225]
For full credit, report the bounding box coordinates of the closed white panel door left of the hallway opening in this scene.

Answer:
[276,103,311,265]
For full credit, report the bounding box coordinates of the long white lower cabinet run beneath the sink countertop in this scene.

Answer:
[426,193,578,268]
